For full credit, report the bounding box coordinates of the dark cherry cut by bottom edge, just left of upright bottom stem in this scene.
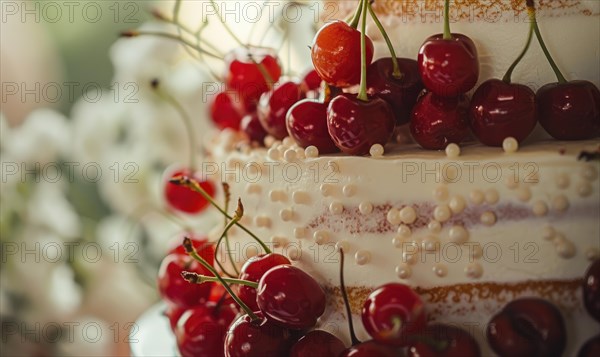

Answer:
[290,330,346,357]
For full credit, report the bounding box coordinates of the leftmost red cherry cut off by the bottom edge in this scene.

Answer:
[175,302,237,357]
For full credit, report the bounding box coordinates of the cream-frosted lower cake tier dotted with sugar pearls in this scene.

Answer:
[202,132,600,355]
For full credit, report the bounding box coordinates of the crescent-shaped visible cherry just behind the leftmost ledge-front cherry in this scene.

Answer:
[257,82,304,140]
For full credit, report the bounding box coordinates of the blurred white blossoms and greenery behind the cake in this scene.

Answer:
[0,0,316,356]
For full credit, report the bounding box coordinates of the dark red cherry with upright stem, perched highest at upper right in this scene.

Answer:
[417,33,479,97]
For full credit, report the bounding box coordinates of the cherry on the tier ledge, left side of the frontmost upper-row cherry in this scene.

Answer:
[286,99,339,154]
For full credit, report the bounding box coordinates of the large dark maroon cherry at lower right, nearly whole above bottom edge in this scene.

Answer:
[486,298,567,356]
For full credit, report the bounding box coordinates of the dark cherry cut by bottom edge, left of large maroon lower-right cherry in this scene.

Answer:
[407,324,481,357]
